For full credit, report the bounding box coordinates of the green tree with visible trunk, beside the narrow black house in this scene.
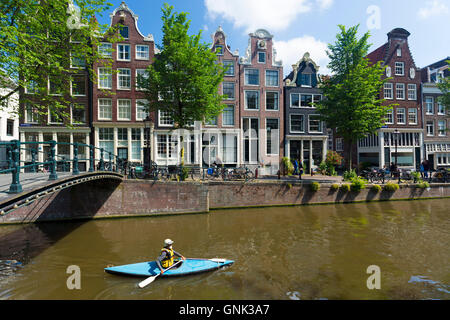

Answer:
[316,25,392,169]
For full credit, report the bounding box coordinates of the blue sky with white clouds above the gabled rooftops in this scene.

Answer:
[98,0,450,75]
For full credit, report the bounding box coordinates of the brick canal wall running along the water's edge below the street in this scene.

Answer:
[0,180,450,224]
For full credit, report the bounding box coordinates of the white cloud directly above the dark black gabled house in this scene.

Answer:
[274,36,330,75]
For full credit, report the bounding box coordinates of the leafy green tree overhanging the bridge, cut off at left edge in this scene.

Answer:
[0,0,120,120]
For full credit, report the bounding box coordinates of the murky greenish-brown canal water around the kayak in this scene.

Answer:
[0,199,450,300]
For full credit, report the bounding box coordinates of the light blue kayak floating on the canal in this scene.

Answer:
[105,258,234,277]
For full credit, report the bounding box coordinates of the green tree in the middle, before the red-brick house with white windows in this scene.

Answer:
[138,4,224,165]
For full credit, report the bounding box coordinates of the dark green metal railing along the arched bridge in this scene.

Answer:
[0,140,124,193]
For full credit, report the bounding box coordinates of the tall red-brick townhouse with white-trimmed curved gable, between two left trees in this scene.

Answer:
[92,2,156,162]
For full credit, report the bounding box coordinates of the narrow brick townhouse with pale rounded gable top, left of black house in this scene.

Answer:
[239,29,284,174]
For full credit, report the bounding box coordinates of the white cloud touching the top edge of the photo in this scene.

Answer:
[205,0,312,33]
